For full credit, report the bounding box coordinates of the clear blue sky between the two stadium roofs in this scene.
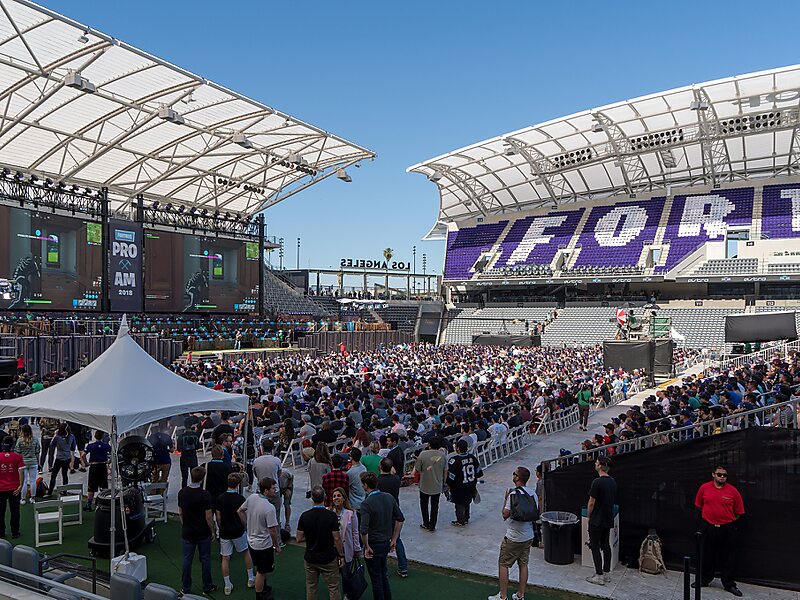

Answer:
[43,0,800,273]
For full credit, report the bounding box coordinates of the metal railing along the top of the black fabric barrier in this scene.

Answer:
[543,399,800,471]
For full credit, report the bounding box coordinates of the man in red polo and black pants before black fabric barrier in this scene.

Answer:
[694,465,744,596]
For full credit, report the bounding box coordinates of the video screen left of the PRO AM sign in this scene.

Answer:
[0,206,103,311]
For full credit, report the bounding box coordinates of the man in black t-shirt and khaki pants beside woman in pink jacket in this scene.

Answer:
[297,486,344,600]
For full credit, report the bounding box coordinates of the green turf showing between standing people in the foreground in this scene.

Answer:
[6,505,578,600]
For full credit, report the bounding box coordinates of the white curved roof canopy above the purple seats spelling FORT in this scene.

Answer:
[408,65,800,239]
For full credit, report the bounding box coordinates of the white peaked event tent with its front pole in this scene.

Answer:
[0,316,248,554]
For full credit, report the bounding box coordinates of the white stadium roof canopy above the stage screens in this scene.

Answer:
[0,0,374,214]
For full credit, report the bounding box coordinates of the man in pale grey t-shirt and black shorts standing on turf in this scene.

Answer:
[239,477,281,600]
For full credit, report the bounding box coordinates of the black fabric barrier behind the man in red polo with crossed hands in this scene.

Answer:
[544,427,800,590]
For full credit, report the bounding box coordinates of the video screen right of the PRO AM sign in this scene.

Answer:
[144,229,260,313]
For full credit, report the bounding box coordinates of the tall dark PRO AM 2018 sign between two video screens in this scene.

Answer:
[108,219,143,312]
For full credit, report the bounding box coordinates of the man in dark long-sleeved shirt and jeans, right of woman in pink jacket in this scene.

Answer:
[359,472,405,600]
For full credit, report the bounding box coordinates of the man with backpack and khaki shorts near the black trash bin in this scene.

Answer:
[489,467,539,600]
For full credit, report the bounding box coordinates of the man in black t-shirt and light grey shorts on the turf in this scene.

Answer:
[215,473,256,596]
